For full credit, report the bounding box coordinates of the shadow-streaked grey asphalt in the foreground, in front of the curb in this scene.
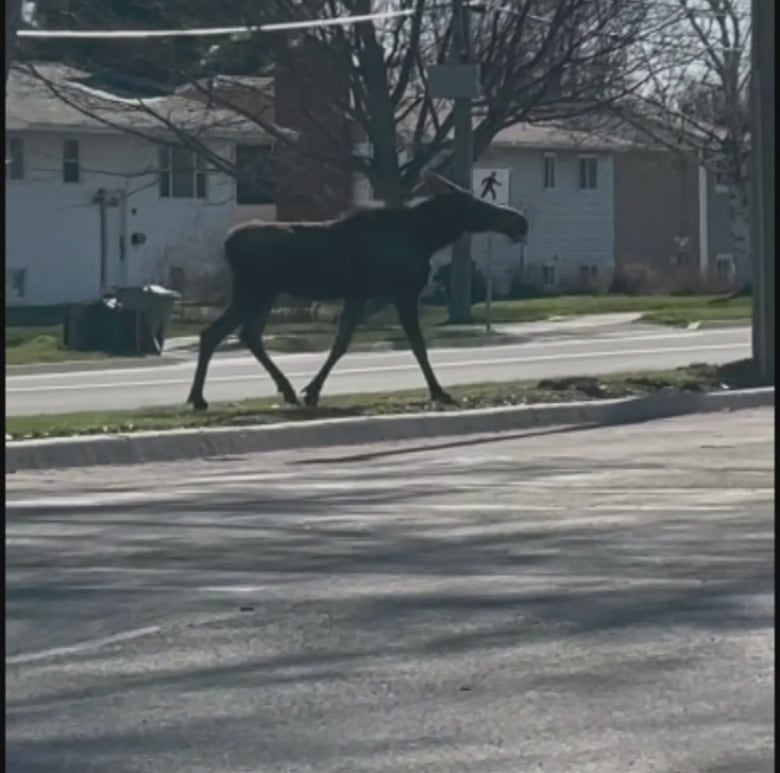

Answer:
[6,409,774,773]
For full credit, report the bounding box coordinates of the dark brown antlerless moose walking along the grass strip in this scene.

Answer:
[187,173,528,410]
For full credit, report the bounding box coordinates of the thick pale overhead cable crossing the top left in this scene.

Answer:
[16,9,414,40]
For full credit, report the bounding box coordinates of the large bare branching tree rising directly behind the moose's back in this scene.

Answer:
[16,0,653,201]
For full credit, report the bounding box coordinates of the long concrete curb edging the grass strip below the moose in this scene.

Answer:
[5,387,775,473]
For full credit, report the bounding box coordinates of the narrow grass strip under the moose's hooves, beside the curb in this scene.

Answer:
[6,360,760,440]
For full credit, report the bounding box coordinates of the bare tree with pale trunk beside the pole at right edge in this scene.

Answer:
[611,0,751,286]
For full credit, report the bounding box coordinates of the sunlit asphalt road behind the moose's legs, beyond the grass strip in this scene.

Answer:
[5,325,750,416]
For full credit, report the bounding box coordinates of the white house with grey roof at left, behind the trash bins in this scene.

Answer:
[5,66,276,305]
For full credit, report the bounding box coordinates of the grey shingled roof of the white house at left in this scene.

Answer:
[5,64,282,138]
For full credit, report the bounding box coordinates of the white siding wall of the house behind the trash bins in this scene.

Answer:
[5,132,250,304]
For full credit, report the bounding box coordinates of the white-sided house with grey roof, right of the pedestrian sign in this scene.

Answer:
[354,124,629,295]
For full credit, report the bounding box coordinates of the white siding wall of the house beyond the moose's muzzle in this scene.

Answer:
[434,149,615,294]
